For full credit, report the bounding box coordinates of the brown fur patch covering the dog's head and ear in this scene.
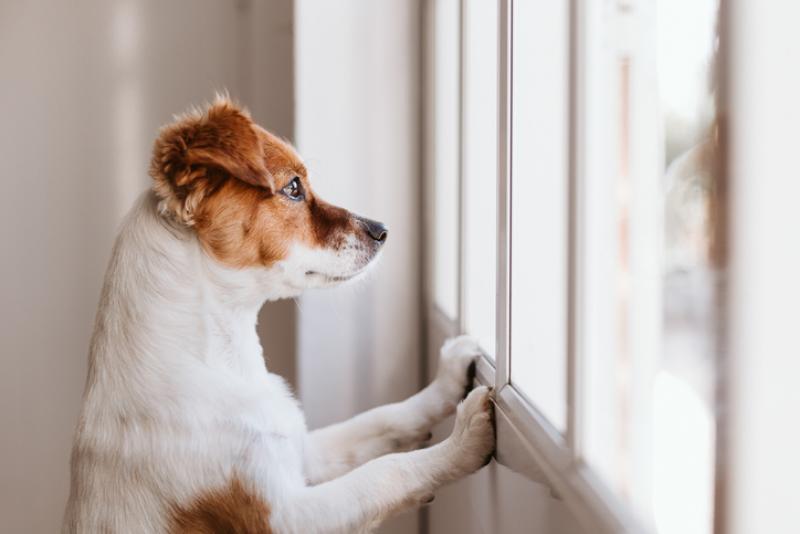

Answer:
[150,98,366,267]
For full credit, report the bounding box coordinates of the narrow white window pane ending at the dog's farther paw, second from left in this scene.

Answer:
[462,0,498,355]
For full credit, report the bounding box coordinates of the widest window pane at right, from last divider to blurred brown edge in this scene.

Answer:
[581,0,720,534]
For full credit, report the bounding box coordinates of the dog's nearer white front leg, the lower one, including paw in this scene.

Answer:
[278,387,494,533]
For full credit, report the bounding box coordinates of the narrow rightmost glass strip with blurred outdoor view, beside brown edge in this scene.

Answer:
[651,0,722,534]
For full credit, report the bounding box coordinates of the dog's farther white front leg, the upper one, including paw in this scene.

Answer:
[305,336,479,484]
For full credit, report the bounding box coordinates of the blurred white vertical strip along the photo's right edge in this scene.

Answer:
[721,0,800,534]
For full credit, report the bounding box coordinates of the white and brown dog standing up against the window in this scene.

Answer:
[63,96,495,534]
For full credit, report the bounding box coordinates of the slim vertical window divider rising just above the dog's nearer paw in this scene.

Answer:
[495,0,514,392]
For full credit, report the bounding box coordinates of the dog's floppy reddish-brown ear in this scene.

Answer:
[150,97,275,225]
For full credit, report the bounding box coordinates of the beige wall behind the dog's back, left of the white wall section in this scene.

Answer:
[0,0,294,534]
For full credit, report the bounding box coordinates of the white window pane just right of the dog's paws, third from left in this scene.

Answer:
[510,0,569,430]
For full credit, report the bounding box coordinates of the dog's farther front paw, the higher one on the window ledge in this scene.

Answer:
[435,336,481,406]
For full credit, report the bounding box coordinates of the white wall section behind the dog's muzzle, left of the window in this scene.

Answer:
[295,0,421,533]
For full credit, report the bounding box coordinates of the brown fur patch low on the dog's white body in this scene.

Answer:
[169,477,272,534]
